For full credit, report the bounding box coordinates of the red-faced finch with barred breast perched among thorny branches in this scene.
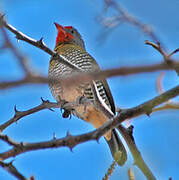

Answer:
[48,22,127,166]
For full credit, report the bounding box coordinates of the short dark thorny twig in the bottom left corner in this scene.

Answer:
[0,161,28,180]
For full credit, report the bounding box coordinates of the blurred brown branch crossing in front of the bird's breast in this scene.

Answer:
[0,63,175,89]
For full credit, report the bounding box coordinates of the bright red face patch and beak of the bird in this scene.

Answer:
[54,23,74,47]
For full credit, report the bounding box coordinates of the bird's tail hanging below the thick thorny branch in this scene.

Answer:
[106,129,127,166]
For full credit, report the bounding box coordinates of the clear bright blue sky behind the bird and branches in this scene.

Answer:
[0,0,179,180]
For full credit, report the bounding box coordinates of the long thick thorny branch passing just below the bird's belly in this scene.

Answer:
[0,86,179,160]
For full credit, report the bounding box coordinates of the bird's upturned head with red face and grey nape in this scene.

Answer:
[54,23,85,49]
